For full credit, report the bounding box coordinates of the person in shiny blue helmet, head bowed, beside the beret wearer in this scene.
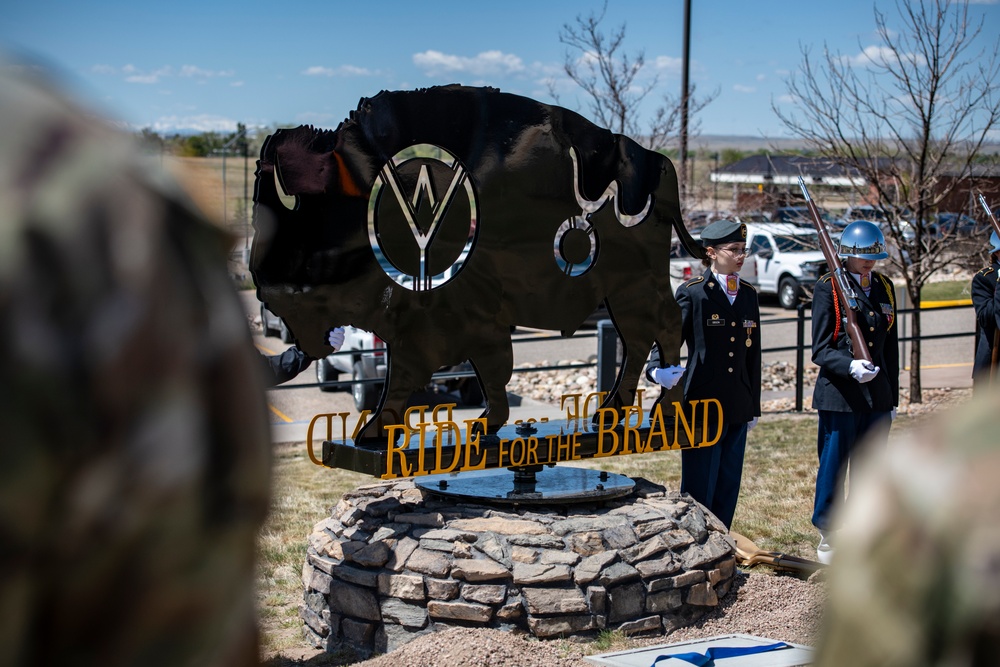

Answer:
[812,220,899,563]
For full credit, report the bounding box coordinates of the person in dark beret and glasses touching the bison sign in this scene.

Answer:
[646,220,761,528]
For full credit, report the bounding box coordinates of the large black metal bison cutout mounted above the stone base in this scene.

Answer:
[250,85,703,446]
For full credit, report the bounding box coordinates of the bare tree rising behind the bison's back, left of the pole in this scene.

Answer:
[549,2,719,155]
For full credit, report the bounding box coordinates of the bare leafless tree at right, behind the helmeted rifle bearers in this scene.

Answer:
[772,0,1000,402]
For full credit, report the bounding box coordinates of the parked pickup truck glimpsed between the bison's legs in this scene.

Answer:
[314,326,483,412]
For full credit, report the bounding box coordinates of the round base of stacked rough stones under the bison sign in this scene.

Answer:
[301,479,736,657]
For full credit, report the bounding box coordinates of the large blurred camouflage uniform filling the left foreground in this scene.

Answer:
[0,62,270,667]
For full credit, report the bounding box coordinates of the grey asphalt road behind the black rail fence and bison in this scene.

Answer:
[242,292,975,434]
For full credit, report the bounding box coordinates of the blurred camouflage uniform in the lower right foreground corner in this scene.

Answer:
[815,388,1000,667]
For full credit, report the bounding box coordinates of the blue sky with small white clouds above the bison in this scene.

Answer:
[0,0,1000,137]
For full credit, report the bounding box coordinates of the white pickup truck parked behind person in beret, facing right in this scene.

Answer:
[740,222,827,309]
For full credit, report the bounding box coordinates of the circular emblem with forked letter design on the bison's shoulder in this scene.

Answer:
[368,144,477,292]
